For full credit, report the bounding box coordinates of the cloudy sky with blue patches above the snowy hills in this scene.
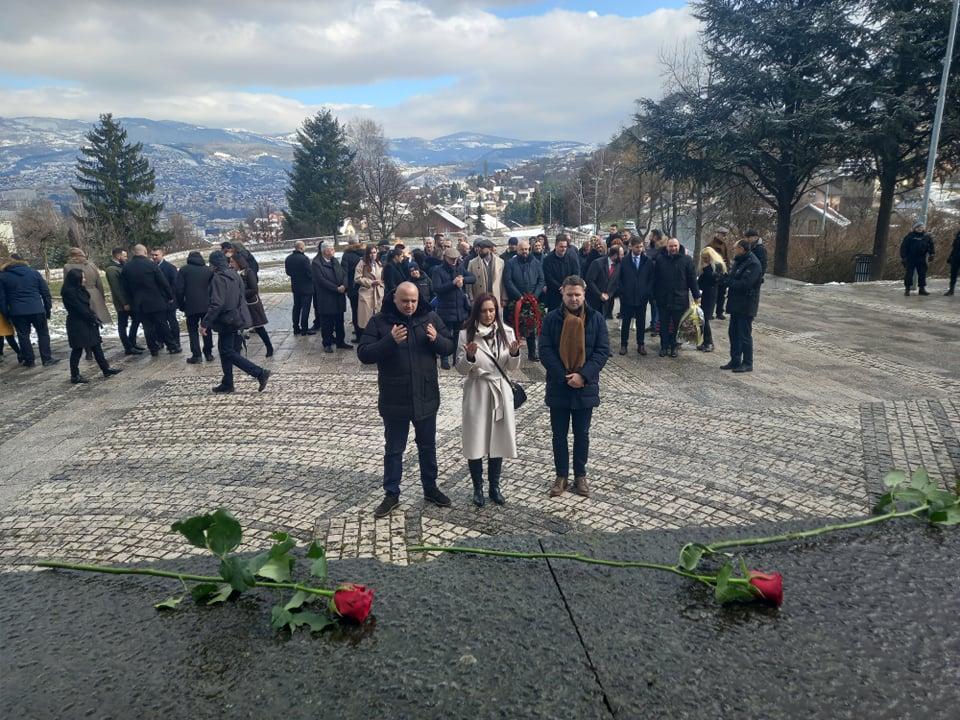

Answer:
[0,0,697,142]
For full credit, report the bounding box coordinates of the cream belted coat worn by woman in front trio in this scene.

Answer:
[456,327,520,460]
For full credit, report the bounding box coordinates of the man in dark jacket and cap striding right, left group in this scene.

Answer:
[200,250,270,393]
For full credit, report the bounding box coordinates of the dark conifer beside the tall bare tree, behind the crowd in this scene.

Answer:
[283,110,357,238]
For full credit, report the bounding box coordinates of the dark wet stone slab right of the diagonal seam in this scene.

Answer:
[542,521,960,719]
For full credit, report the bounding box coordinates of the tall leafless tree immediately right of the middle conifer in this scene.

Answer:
[347,118,408,240]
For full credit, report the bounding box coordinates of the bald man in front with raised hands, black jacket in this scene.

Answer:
[357,282,456,518]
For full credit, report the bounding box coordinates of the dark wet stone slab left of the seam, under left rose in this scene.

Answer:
[0,540,610,719]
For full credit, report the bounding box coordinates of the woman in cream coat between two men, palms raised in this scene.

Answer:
[456,293,520,507]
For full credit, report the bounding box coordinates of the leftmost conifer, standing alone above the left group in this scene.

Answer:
[73,113,167,246]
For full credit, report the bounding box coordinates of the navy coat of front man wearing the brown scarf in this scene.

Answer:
[540,305,610,410]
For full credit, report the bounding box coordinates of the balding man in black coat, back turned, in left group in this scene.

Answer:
[120,245,180,357]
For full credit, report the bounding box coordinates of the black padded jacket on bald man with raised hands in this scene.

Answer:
[357,293,456,421]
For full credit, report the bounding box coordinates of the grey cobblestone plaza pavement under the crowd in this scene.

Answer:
[0,281,960,569]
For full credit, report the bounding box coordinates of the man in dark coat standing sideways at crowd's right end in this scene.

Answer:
[720,240,763,373]
